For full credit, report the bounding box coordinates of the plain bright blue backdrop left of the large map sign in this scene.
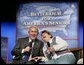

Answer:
[1,22,16,62]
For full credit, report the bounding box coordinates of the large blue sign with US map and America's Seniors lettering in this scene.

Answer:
[16,2,79,48]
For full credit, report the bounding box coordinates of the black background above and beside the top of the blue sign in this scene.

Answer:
[1,0,84,22]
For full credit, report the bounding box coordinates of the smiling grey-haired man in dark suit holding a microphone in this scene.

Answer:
[11,26,43,64]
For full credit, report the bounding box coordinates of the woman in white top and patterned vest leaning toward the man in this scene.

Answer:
[41,30,76,64]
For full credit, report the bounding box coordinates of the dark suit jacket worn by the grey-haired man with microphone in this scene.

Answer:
[11,37,43,60]
